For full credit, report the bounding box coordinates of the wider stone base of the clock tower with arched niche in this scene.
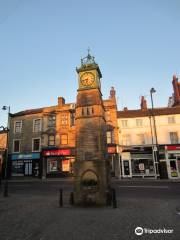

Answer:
[74,160,110,206]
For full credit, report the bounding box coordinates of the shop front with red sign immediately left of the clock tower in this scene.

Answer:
[42,148,75,178]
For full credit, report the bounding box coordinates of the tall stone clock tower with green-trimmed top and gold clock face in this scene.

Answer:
[74,53,110,205]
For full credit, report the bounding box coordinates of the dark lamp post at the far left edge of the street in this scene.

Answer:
[2,106,10,197]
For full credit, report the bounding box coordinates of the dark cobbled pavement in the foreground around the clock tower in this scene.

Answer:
[0,183,180,240]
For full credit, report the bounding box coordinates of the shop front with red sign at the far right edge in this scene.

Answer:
[165,145,180,179]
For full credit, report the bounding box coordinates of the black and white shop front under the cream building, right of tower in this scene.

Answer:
[121,147,156,178]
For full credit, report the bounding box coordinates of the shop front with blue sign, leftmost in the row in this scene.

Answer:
[11,153,40,177]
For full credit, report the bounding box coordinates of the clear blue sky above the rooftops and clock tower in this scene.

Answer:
[0,0,180,124]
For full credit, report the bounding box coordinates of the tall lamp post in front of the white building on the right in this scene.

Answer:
[150,88,159,178]
